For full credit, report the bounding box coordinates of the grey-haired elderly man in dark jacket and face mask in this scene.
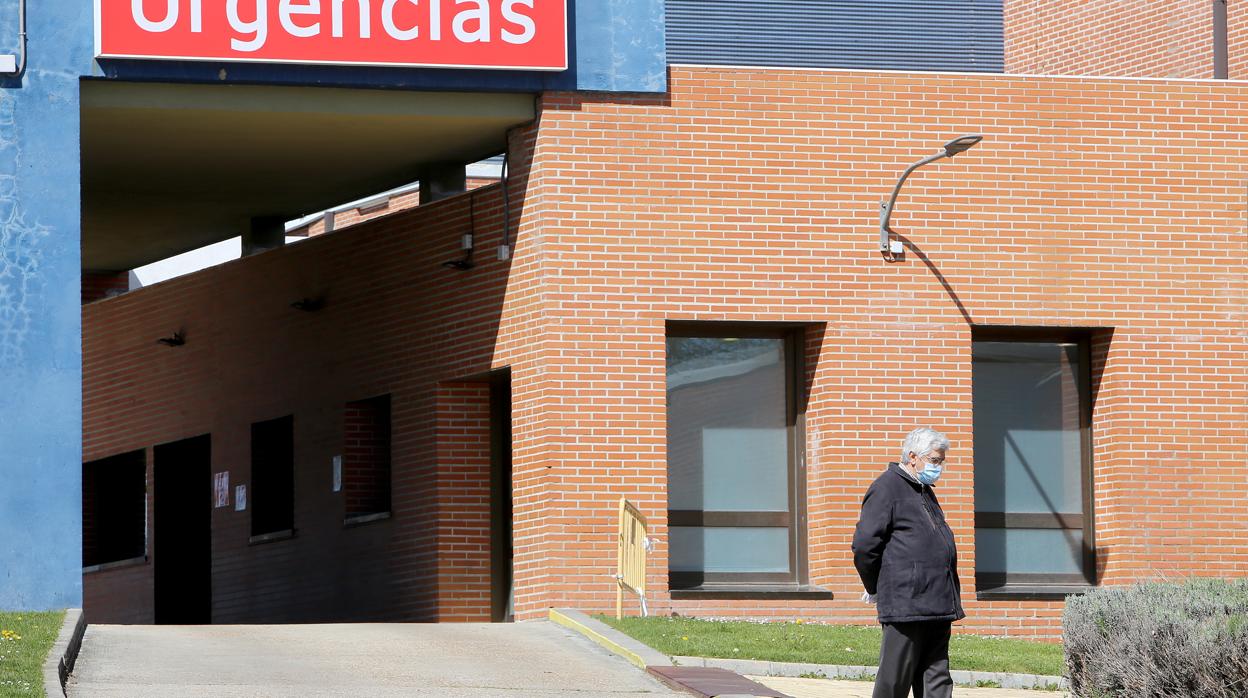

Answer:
[854,427,966,698]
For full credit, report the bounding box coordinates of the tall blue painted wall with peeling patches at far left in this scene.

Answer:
[0,0,92,611]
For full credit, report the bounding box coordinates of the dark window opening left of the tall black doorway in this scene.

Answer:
[82,451,147,567]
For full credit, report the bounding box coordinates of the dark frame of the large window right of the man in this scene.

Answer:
[971,326,1101,598]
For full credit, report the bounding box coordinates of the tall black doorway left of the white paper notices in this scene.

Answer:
[152,436,212,626]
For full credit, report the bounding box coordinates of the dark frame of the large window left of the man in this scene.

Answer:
[664,321,809,592]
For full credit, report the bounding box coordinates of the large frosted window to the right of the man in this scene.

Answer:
[972,330,1096,592]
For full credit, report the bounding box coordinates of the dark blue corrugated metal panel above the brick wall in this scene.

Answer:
[666,0,1005,72]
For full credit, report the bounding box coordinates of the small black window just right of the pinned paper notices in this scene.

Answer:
[251,417,295,537]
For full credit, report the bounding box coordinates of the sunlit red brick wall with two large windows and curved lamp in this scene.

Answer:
[530,66,1248,637]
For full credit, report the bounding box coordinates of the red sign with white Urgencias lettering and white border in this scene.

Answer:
[95,0,568,70]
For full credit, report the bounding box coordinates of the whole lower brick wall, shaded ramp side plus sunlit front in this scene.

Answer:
[85,66,1248,637]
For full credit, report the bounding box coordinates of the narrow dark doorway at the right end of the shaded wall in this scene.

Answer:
[489,371,513,623]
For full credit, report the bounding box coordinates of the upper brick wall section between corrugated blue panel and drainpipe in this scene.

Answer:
[1005,0,1218,77]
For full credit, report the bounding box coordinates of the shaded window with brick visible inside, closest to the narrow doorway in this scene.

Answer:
[342,395,391,521]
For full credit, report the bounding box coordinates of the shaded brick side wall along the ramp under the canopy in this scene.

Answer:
[84,140,534,622]
